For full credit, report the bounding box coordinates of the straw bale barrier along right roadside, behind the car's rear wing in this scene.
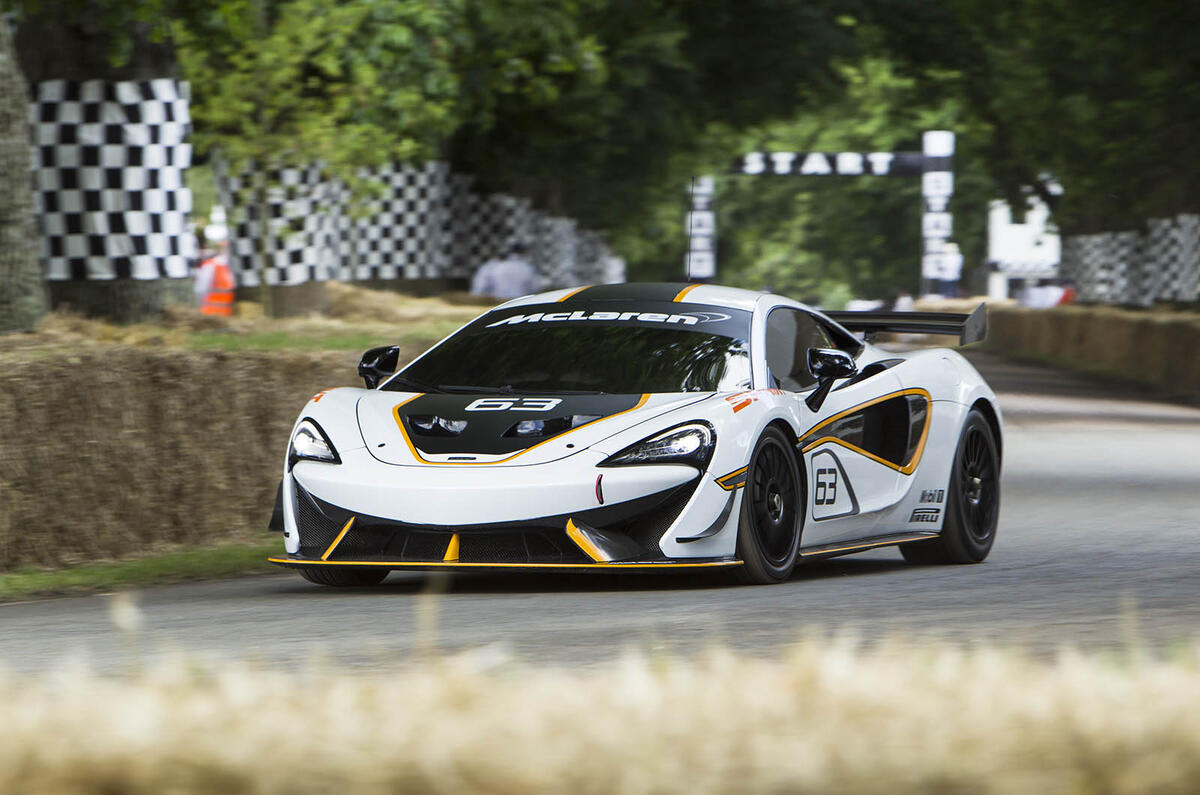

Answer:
[988,306,1200,398]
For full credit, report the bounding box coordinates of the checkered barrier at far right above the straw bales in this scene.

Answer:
[1060,215,1200,306]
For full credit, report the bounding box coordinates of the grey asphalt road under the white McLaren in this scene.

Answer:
[0,354,1200,670]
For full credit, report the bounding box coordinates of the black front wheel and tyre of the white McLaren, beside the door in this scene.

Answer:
[737,428,804,585]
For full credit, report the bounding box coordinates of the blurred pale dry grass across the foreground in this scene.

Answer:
[0,640,1200,795]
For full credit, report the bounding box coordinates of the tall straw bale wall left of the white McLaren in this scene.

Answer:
[0,345,356,572]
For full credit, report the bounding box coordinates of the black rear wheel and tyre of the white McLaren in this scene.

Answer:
[900,410,1000,563]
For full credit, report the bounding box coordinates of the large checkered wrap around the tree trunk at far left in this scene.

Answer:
[30,78,196,281]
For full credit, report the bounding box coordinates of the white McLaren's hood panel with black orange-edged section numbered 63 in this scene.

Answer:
[358,391,710,466]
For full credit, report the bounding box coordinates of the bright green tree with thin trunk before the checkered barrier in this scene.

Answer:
[174,0,457,313]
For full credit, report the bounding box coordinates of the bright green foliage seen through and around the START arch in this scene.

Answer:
[700,55,991,307]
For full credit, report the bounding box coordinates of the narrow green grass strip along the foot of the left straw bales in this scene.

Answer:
[0,540,281,602]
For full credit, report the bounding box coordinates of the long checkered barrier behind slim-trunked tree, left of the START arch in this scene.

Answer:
[217,162,624,286]
